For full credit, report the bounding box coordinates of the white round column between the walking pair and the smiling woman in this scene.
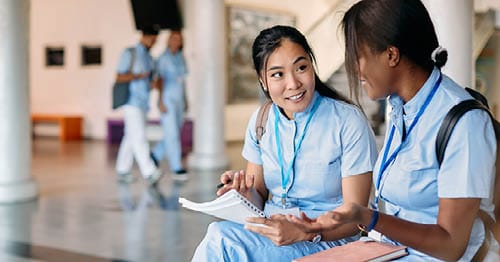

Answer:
[185,0,228,170]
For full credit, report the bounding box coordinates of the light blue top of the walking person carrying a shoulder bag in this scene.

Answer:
[117,43,154,112]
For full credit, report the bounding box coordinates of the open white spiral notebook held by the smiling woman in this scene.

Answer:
[179,189,266,224]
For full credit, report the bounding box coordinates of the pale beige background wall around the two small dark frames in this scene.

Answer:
[30,0,344,140]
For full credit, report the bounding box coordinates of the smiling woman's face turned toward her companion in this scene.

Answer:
[260,39,315,119]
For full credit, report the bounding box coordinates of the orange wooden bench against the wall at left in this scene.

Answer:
[31,114,83,142]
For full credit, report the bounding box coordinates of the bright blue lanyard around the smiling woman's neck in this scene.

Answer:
[274,96,321,208]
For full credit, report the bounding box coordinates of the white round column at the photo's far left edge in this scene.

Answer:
[0,0,37,203]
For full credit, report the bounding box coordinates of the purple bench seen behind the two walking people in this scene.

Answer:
[106,119,193,156]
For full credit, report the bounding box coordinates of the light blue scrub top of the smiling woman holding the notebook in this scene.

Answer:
[242,92,377,217]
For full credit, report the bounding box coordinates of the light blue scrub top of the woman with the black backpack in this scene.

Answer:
[373,68,496,261]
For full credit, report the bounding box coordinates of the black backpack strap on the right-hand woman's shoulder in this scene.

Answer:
[436,99,493,166]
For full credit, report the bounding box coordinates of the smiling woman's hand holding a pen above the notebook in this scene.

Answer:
[217,170,255,196]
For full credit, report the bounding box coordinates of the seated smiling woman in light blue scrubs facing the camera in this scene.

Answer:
[192,26,377,261]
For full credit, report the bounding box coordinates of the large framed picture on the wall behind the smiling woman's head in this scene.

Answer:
[227,6,295,104]
